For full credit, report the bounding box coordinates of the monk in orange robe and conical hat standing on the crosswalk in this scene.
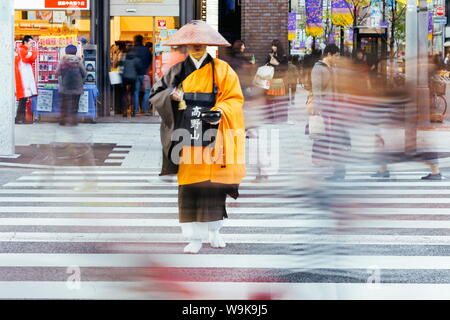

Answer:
[150,20,246,253]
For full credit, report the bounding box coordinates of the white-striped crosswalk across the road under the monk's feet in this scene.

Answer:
[0,167,450,299]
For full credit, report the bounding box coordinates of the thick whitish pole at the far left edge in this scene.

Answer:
[0,0,16,156]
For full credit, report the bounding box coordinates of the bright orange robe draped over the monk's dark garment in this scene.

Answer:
[178,59,246,185]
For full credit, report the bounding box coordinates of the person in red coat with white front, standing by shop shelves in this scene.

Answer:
[15,36,37,123]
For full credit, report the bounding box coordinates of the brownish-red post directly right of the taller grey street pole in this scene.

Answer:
[417,0,430,125]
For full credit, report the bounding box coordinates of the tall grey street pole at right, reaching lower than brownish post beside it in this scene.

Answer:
[405,0,418,154]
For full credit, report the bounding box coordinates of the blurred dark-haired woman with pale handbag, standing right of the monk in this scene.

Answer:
[266,39,289,122]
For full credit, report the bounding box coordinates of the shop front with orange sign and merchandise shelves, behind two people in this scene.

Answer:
[15,0,98,120]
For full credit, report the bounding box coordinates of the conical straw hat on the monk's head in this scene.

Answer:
[164,20,231,47]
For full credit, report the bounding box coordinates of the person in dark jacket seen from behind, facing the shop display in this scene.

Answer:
[56,45,87,126]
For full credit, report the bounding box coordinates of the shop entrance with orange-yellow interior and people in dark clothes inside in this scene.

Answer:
[110,16,179,122]
